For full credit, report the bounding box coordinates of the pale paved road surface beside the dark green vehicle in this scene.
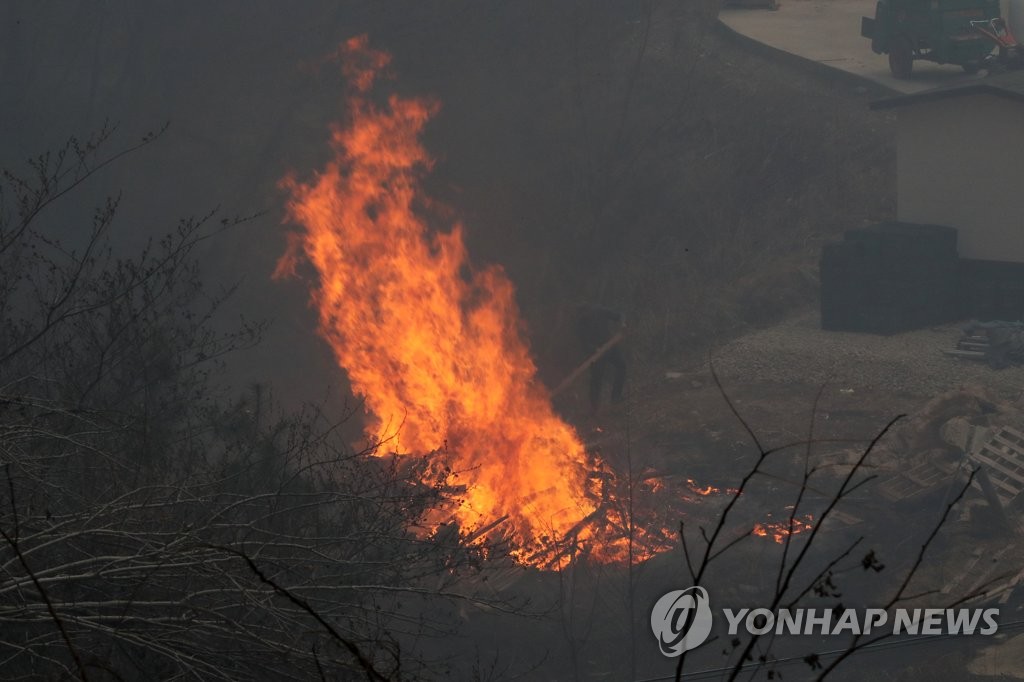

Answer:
[719,0,978,92]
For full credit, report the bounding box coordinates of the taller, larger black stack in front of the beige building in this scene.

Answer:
[821,222,962,334]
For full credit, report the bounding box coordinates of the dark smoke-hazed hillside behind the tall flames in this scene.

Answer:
[3,0,893,397]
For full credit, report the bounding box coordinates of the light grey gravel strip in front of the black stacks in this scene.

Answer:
[714,311,1024,400]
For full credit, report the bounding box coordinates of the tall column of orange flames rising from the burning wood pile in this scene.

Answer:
[274,36,659,563]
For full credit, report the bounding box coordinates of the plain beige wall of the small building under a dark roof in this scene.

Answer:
[897,94,1024,262]
